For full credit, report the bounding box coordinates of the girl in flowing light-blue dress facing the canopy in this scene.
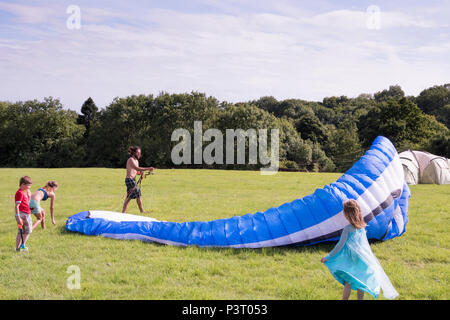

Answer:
[321,200,398,300]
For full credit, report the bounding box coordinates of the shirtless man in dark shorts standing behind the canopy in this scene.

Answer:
[122,146,154,213]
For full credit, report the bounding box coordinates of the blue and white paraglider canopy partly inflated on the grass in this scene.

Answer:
[66,136,410,248]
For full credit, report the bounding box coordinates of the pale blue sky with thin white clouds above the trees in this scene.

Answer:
[0,0,450,111]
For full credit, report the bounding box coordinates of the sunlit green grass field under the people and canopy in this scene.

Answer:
[0,168,450,300]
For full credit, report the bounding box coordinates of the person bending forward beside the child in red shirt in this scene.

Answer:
[30,181,58,229]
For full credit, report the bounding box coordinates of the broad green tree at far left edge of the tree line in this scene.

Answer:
[0,97,85,168]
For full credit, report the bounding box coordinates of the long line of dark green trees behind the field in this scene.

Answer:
[0,84,450,172]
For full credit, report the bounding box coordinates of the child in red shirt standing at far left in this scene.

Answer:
[15,176,33,251]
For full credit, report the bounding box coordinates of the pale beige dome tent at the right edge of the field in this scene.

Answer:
[399,150,450,184]
